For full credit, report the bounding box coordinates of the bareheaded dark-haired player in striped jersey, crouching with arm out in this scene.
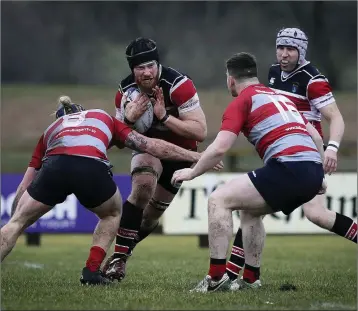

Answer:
[172,53,325,292]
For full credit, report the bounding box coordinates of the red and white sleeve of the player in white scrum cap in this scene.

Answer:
[307,76,335,109]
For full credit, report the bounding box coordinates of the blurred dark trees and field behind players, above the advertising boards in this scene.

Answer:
[1,1,357,173]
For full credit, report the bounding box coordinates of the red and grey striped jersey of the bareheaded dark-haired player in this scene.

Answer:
[220,84,322,163]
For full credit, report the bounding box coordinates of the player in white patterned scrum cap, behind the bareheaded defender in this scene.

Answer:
[227,28,357,286]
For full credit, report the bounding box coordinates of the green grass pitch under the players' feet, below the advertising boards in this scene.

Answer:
[1,235,357,310]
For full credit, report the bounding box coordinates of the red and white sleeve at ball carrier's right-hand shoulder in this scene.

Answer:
[169,76,200,114]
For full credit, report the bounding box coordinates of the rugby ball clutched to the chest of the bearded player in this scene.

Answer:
[121,87,154,134]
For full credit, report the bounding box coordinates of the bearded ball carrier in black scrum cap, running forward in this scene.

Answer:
[103,38,215,281]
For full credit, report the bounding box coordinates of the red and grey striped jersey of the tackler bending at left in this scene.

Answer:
[29,109,132,169]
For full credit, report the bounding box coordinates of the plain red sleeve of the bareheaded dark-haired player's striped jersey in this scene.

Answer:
[220,96,250,135]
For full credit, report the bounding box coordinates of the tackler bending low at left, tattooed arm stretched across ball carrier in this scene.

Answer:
[1,96,204,285]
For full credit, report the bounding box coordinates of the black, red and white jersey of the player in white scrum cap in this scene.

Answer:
[268,62,335,137]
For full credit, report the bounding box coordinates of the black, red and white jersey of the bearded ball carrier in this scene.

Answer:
[115,65,200,150]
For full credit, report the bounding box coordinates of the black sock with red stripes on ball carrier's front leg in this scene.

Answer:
[114,201,143,257]
